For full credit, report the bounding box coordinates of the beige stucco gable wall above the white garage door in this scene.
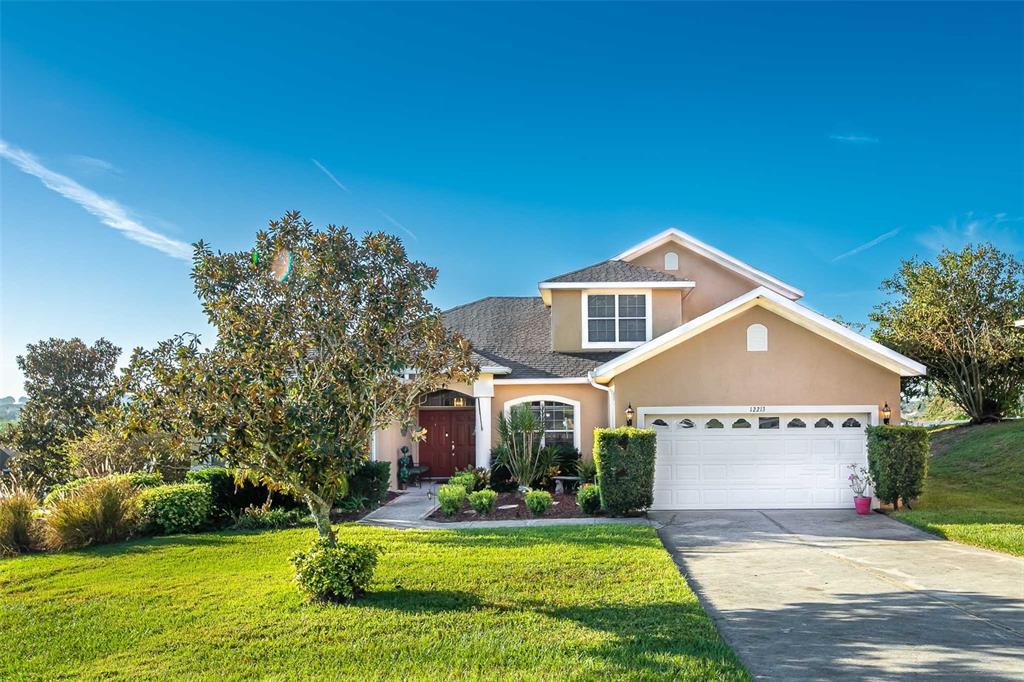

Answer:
[612,307,900,423]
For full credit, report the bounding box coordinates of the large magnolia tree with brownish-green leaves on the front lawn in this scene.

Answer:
[121,212,477,546]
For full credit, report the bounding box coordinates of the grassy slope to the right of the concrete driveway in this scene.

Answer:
[895,420,1024,556]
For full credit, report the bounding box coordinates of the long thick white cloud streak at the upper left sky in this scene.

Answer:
[0,139,193,261]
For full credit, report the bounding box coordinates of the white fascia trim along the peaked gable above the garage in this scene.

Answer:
[592,287,928,383]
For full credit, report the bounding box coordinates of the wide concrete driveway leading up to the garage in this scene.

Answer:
[650,510,1024,680]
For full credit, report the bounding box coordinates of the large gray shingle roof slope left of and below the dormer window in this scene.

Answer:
[444,296,625,379]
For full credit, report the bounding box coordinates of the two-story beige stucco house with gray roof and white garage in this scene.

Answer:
[374,228,925,509]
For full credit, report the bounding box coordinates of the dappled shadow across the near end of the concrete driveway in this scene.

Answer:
[722,591,1024,680]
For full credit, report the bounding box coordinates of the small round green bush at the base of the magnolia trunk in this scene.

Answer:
[292,540,379,602]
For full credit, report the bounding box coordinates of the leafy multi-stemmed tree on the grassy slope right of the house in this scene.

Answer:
[870,244,1024,423]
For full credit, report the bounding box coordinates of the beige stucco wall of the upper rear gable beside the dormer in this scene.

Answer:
[631,242,758,323]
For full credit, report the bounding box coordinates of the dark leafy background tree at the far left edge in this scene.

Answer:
[5,338,121,484]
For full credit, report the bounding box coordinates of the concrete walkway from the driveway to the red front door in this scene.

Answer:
[359,483,651,530]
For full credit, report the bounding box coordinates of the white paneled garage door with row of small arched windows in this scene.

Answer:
[644,412,870,509]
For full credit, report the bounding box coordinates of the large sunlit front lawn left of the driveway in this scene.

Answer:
[0,525,748,680]
